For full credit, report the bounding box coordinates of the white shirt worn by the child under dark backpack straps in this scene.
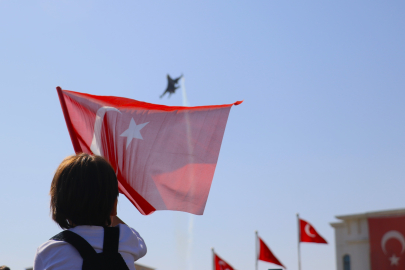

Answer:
[34,224,146,270]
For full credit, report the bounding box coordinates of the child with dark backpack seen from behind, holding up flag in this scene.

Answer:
[34,153,146,270]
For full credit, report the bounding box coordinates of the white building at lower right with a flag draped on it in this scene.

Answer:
[330,209,405,270]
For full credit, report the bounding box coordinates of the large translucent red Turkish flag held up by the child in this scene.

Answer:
[57,87,241,215]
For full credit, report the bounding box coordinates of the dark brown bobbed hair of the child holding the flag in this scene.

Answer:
[50,153,118,229]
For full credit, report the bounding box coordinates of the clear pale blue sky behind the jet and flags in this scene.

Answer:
[0,0,405,270]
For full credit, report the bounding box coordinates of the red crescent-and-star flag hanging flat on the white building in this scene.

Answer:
[368,216,405,270]
